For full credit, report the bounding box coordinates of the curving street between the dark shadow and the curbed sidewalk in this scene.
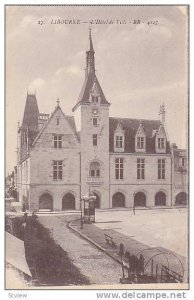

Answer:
[39,215,122,285]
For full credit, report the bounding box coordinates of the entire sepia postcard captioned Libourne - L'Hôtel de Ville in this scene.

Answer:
[5,5,190,292]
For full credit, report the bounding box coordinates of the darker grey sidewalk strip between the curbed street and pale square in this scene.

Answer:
[68,219,188,282]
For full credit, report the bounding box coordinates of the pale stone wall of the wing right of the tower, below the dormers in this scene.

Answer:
[110,153,172,207]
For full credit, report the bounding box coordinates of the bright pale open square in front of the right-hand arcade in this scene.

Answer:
[95,208,188,257]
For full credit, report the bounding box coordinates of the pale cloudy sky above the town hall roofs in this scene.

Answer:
[6,6,188,172]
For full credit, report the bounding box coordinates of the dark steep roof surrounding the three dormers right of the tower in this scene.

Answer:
[109,117,169,153]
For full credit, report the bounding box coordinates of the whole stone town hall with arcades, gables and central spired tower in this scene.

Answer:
[17,31,188,211]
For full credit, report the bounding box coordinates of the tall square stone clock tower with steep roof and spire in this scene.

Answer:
[73,29,110,208]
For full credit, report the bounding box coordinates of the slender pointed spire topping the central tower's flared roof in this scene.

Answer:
[85,28,95,78]
